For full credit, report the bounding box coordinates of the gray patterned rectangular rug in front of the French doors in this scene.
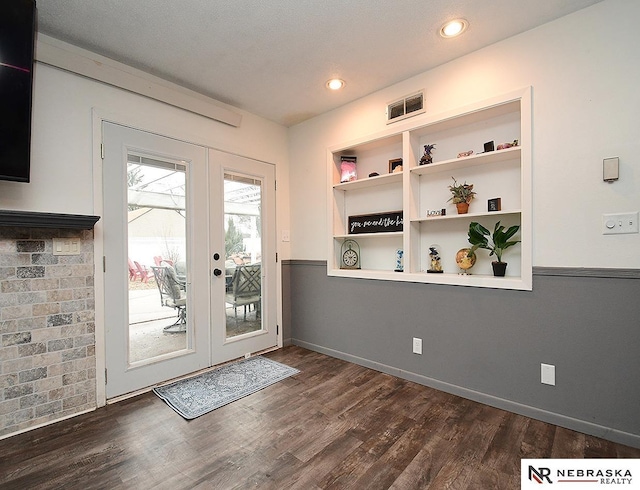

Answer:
[153,356,300,420]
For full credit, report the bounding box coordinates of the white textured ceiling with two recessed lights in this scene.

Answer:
[37,0,601,126]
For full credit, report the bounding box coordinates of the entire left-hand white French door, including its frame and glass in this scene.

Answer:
[102,121,210,399]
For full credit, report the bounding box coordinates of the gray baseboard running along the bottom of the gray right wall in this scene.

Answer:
[291,339,640,448]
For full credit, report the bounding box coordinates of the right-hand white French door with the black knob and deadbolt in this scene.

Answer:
[209,150,277,364]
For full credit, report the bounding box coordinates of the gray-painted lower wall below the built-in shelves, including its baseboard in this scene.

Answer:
[282,260,640,447]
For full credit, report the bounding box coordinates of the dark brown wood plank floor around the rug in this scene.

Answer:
[0,347,640,490]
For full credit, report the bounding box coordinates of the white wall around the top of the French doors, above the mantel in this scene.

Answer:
[0,63,289,256]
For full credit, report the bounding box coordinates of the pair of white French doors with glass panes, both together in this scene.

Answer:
[103,122,277,398]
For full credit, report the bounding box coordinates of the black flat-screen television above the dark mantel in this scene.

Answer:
[0,0,36,182]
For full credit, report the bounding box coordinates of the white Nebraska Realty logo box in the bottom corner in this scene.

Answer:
[520,459,640,490]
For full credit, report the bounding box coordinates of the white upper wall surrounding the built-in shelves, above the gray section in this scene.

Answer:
[290,0,640,268]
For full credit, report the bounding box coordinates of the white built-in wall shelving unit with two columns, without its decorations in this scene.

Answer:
[327,87,532,290]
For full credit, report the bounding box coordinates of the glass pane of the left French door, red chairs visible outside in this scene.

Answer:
[127,154,188,364]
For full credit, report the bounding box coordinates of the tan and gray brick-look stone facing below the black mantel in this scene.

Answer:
[0,227,96,437]
